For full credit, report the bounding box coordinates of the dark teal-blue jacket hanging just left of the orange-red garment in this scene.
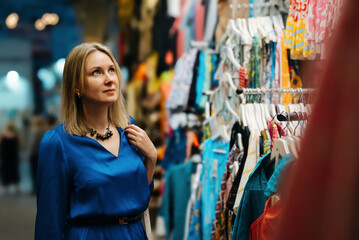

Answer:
[231,153,274,240]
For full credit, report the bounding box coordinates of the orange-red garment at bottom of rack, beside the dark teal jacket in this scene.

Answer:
[249,197,283,240]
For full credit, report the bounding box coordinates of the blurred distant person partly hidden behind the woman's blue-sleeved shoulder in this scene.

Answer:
[30,116,48,194]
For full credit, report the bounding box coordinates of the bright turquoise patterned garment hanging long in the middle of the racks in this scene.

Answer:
[202,138,229,240]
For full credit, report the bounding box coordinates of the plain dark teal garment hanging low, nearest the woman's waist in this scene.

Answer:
[158,161,194,240]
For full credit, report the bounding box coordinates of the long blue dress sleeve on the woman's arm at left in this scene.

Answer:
[35,130,70,240]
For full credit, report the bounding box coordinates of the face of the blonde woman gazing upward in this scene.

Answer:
[81,51,119,104]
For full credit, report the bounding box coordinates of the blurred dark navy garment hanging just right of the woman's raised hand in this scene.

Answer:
[161,127,187,170]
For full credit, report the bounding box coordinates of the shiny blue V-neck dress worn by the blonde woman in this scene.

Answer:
[35,124,153,240]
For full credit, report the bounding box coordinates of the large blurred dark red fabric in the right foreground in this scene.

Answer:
[277,0,359,240]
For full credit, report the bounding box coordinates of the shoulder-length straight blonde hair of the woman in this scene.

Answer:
[61,43,127,136]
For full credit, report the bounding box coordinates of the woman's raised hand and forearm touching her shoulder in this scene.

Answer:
[125,124,157,183]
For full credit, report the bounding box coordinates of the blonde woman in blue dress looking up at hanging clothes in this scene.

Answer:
[35,43,157,240]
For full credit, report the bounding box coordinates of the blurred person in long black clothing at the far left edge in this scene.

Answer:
[0,121,20,193]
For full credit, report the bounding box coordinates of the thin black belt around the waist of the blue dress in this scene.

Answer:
[66,214,143,226]
